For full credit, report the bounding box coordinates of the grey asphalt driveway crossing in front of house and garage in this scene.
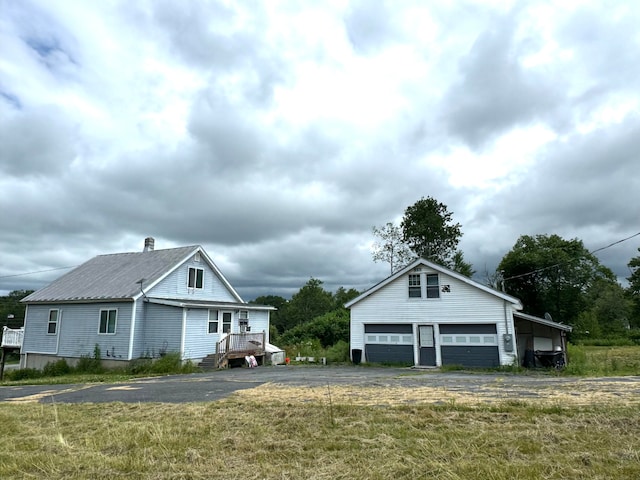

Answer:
[0,366,640,403]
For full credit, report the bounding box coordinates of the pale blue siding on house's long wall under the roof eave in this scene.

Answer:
[22,302,133,360]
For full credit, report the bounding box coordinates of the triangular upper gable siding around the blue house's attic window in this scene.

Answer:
[145,257,238,302]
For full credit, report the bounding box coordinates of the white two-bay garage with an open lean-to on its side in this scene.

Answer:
[345,259,571,367]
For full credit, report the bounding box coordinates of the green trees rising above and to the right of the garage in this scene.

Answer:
[372,197,640,341]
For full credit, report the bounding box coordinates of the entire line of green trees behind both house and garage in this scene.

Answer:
[0,197,640,348]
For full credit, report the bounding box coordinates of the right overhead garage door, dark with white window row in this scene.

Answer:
[440,324,500,368]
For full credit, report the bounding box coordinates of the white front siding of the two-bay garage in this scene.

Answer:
[351,267,516,365]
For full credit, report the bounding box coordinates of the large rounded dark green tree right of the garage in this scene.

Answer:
[498,235,615,325]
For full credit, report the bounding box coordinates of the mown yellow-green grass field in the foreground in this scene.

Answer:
[0,385,640,480]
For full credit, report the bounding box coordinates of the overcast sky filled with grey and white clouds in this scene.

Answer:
[0,0,640,300]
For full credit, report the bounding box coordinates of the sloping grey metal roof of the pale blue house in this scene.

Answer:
[22,245,202,303]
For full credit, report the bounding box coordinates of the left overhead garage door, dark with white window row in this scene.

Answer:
[364,324,414,365]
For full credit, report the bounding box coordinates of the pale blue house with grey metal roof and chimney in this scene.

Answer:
[21,238,275,368]
